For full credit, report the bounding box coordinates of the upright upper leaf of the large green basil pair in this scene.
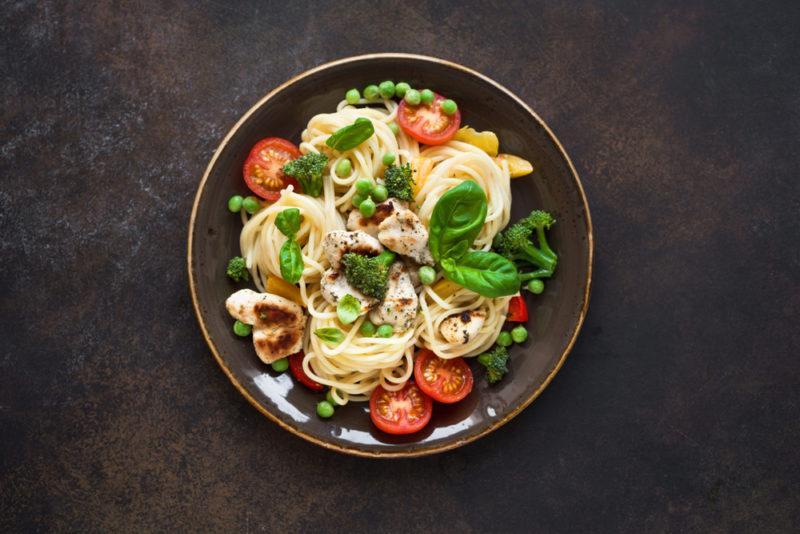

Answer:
[428,180,488,262]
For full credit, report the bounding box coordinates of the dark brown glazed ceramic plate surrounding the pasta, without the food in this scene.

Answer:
[188,54,593,457]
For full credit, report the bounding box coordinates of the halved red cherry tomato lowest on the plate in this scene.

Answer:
[369,380,433,434]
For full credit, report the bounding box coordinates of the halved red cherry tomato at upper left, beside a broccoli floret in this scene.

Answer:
[243,137,301,202]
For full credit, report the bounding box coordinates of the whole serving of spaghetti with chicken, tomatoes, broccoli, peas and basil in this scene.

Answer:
[219,80,558,434]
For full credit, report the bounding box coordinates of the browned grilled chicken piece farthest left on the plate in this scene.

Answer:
[225,289,306,363]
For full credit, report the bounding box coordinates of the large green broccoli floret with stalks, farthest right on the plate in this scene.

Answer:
[494,210,558,282]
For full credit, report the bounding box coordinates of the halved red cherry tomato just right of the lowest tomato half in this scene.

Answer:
[414,349,472,404]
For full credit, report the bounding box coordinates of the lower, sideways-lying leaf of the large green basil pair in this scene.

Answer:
[441,250,519,298]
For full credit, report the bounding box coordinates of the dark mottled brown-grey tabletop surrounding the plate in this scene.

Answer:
[0,0,800,532]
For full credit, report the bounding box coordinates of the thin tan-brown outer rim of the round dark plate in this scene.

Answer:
[186,52,594,458]
